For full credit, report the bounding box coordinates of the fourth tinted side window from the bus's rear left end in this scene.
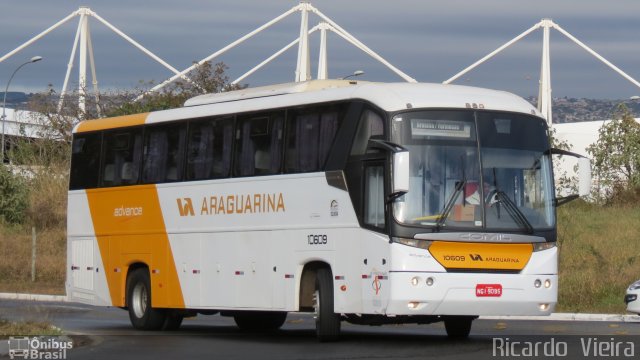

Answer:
[186,118,233,180]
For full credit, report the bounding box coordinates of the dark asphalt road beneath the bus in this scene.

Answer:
[0,300,640,360]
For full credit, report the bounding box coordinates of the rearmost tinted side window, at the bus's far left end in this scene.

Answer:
[69,133,102,190]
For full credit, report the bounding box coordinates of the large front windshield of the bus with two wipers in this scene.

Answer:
[391,110,555,233]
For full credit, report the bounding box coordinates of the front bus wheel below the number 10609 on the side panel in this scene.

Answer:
[313,268,341,342]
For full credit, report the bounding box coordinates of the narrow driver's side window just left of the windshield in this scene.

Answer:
[364,164,385,228]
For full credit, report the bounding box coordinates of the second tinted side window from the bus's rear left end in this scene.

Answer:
[102,129,142,186]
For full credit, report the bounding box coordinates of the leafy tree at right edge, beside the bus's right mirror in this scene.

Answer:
[587,104,640,198]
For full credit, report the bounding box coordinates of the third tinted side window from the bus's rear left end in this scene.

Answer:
[142,124,186,183]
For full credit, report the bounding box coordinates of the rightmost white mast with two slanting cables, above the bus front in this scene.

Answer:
[442,19,640,125]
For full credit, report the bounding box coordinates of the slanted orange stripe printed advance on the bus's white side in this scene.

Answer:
[86,185,184,308]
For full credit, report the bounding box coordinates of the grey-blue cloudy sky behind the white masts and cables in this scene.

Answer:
[0,0,640,99]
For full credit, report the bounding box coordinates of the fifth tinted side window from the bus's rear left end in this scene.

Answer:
[235,113,284,176]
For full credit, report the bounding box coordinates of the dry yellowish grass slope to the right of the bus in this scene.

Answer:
[556,200,640,314]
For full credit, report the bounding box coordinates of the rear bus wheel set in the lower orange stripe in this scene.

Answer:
[127,268,166,330]
